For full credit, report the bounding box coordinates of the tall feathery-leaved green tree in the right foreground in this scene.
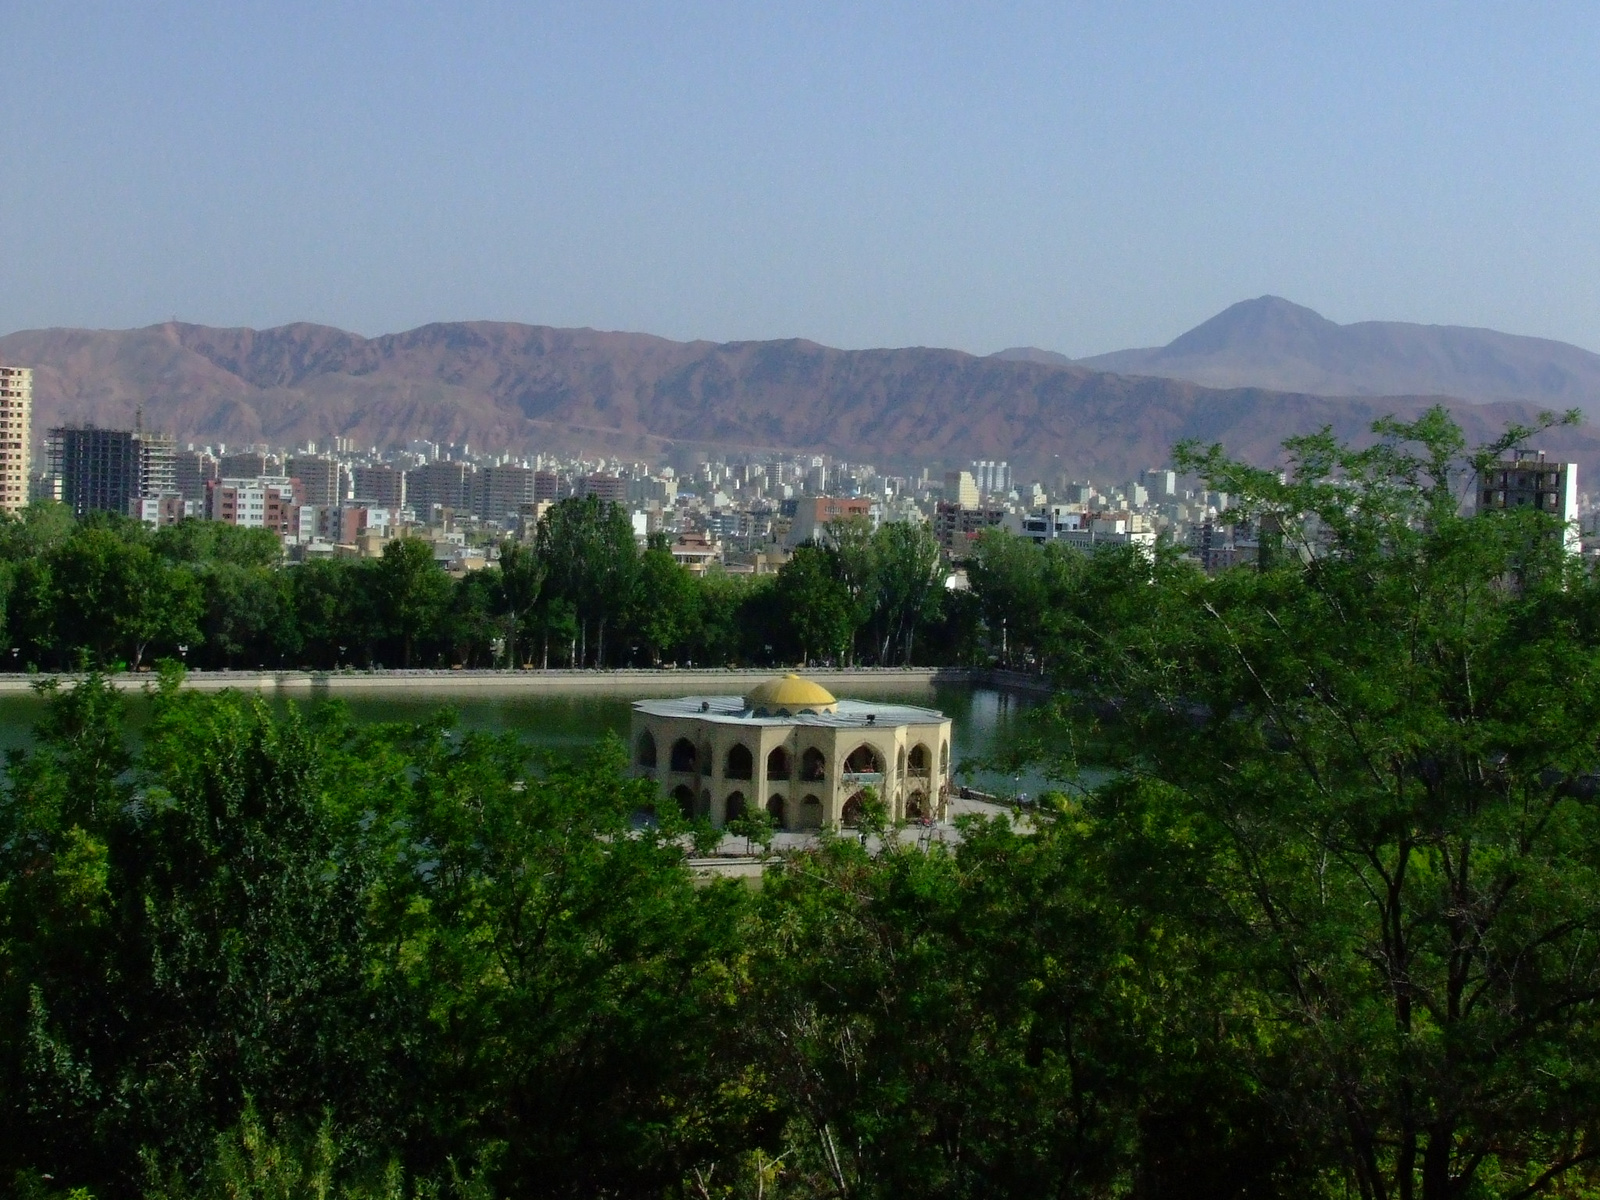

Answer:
[1036,410,1600,1200]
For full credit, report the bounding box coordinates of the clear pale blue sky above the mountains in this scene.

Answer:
[0,0,1600,357]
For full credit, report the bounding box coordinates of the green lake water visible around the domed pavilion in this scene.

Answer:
[0,685,1045,794]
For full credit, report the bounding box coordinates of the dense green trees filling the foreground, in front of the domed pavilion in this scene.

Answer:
[0,411,1600,1200]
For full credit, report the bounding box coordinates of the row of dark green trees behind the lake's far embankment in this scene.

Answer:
[0,498,976,670]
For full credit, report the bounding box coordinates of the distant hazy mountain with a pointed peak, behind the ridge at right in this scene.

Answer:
[1068,296,1600,419]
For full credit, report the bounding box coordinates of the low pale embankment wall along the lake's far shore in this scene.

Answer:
[0,667,1050,698]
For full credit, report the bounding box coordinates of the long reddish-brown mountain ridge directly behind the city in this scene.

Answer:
[0,322,1600,480]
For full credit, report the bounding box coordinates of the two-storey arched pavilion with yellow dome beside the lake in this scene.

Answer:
[632,675,950,830]
